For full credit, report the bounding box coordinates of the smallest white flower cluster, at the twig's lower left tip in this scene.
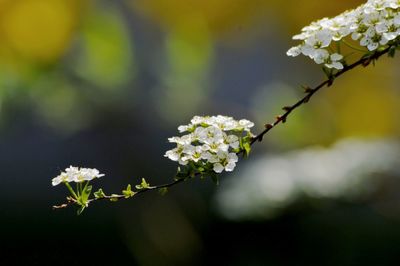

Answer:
[51,166,104,186]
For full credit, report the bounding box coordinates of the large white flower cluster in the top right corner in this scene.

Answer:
[287,0,400,69]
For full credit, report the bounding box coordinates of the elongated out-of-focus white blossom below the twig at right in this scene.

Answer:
[216,139,400,219]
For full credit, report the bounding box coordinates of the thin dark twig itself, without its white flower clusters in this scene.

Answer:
[53,46,393,212]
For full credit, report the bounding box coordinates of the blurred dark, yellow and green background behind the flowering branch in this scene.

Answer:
[0,0,400,266]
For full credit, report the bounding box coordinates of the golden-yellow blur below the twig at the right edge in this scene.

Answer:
[328,59,400,137]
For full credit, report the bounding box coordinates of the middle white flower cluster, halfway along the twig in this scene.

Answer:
[164,115,254,173]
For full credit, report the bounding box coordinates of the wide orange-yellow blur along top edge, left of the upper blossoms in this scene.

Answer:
[130,0,365,38]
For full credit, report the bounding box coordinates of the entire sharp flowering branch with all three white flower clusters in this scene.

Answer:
[52,0,400,214]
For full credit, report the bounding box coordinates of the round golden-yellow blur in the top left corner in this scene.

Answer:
[0,0,79,63]
